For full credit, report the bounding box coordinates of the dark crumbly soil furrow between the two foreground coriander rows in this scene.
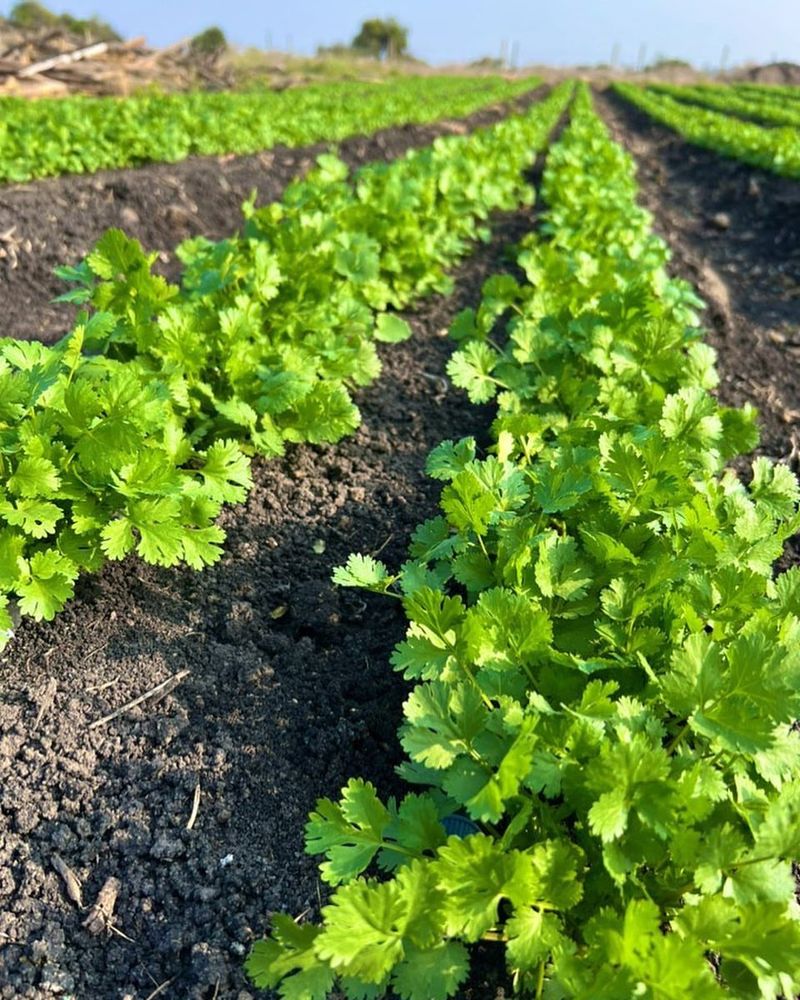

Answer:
[0,199,532,1000]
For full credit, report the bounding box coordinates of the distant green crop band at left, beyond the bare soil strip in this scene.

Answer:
[0,77,539,182]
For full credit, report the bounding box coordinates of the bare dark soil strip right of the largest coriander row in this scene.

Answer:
[597,87,800,568]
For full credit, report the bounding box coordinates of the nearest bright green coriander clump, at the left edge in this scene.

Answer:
[0,328,250,644]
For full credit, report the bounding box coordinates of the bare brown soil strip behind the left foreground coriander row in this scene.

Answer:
[0,88,543,342]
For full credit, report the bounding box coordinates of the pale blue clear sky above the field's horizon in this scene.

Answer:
[7,0,800,66]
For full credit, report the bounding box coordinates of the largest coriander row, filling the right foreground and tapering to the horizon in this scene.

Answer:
[247,84,800,1000]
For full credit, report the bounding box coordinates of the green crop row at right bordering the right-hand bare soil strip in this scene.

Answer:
[614,83,800,177]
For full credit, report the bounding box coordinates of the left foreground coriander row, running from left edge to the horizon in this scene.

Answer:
[0,85,571,647]
